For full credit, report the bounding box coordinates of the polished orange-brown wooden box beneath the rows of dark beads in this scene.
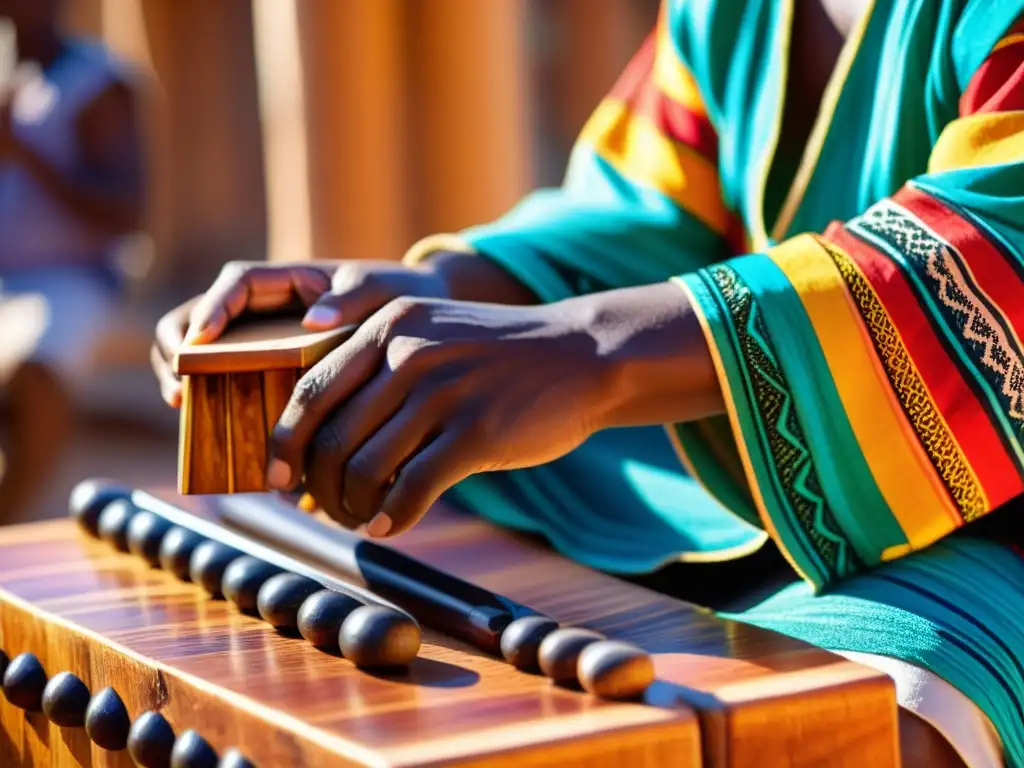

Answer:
[0,494,899,768]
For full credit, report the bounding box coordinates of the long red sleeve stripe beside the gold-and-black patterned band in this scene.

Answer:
[825,226,1024,506]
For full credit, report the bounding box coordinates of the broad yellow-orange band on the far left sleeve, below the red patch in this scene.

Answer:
[580,99,729,234]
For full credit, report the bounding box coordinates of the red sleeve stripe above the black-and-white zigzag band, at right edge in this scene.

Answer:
[893,186,1024,348]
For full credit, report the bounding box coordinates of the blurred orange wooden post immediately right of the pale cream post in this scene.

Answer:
[288,0,407,259]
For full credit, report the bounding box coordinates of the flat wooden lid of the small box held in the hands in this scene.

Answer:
[174,317,352,376]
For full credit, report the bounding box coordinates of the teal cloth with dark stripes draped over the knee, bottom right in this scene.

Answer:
[723,537,1024,766]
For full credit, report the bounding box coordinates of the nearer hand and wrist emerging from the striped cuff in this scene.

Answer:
[268,284,721,536]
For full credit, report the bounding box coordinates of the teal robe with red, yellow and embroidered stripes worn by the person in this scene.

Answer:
[405,0,1024,764]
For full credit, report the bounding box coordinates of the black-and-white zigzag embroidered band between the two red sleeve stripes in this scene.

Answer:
[847,200,1024,440]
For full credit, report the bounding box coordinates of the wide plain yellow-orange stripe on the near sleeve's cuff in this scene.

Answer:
[769,234,959,546]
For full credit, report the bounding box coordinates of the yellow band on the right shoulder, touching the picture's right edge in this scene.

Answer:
[928,111,1024,173]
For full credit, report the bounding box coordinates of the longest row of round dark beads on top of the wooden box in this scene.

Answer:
[79,498,421,668]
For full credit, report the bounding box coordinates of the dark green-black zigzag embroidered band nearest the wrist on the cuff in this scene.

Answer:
[702,264,858,575]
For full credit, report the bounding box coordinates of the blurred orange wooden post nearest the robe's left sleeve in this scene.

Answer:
[407,0,534,236]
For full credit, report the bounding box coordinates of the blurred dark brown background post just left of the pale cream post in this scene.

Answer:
[138,0,265,293]
